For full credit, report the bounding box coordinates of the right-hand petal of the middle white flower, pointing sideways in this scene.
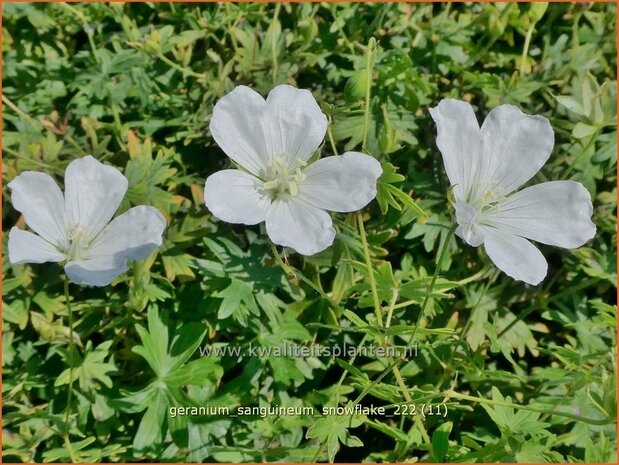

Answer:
[299,152,383,212]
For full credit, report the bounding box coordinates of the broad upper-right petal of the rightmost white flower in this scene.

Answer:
[477,105,554,198]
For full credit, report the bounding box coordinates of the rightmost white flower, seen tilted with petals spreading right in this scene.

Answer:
[430,99,595,284]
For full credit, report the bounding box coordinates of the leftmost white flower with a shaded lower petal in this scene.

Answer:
[8,156,166,286]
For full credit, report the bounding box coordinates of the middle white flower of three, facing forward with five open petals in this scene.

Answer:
[204,85,382,255]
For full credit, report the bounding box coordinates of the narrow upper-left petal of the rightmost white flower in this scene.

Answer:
[430,99,482,201]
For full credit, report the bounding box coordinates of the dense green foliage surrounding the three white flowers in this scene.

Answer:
[2,3,617,462]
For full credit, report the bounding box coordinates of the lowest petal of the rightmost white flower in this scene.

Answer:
[484,229,548,285]
